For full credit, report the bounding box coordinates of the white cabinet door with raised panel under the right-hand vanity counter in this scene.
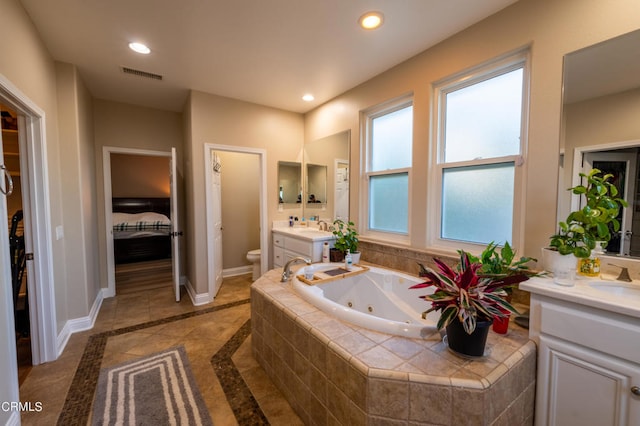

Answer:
[536,335,640,426]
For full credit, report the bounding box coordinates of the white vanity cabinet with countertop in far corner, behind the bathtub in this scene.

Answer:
[272,228,335,268]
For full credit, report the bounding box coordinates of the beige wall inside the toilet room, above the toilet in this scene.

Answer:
[218,151,261,269]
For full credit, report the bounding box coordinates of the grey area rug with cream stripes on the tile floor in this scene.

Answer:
[92,346,213,425]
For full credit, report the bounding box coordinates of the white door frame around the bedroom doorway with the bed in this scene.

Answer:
[102,146,172,297]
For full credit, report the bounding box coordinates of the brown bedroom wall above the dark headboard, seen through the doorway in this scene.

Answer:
[111,154,171,198]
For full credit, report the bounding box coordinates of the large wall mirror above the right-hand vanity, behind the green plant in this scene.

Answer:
[558,30,640,257]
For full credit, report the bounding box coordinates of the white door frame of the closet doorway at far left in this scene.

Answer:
[0,74,58,365]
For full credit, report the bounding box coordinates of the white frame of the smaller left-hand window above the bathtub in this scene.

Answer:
[360,93,415,244]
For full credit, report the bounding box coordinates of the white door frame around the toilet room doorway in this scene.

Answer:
[204,143,269,302]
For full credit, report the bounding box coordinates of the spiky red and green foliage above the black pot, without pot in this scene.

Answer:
[411,250,529,334]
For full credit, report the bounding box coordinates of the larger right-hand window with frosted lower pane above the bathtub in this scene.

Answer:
[429,51,528,252]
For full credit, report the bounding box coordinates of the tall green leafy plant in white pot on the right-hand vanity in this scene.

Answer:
[543,169,629,285]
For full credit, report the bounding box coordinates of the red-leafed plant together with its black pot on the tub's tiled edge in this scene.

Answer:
[411,250,529,356]
